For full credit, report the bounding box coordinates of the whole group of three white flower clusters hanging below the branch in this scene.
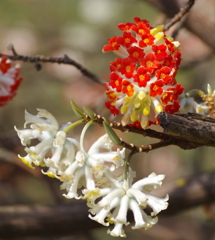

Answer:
[15,109,168,237]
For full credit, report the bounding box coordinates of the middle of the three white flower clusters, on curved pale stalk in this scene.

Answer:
[59,134,125,199]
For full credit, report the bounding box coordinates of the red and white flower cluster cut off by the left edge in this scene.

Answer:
[0,57,22,107]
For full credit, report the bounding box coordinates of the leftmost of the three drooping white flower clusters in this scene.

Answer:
[15,109,79,172]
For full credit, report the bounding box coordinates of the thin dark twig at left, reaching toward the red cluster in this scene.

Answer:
[0,48,104,85]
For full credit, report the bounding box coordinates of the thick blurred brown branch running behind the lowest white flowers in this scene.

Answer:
[0,172,215,239]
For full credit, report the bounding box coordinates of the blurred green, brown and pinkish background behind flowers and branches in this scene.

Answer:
[0,0,215,240]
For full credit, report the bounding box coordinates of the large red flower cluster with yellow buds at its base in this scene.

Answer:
[103,18,184,129]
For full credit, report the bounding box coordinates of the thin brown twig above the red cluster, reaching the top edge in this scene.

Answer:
[164,0,195,31]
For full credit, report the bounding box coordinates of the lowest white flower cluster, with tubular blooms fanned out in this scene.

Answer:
[84,173,168,237]
